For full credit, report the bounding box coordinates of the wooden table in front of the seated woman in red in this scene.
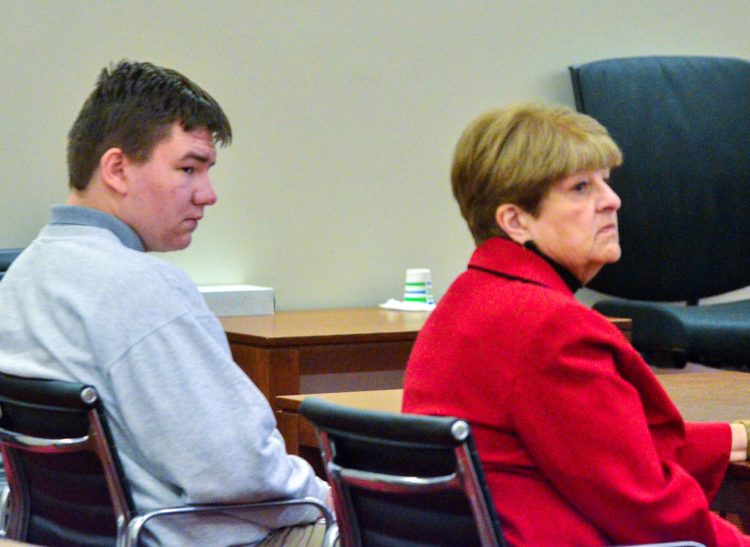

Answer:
[276,371,750,520]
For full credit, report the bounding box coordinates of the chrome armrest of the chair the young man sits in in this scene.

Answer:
[123,498,338,547]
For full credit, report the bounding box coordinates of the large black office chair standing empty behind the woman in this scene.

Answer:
[570,56,750,368]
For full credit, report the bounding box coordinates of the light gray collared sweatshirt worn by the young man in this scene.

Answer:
[0,206,328,546]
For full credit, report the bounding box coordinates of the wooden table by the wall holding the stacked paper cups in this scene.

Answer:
[220,308,632,408]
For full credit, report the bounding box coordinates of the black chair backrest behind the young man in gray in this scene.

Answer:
[0,373,134,546]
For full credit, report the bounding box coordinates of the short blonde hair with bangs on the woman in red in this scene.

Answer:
[451,103,622,245]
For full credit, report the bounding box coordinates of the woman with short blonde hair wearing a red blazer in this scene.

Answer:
[403,105,750,546]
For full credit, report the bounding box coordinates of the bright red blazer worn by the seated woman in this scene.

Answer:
[403,238,750,547]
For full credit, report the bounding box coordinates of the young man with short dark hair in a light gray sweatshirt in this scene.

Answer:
[0,62,328,545]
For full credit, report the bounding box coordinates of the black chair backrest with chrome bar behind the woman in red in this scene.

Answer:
[300,397,505,547]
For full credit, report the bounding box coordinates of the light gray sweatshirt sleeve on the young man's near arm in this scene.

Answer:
[105,314,328,528]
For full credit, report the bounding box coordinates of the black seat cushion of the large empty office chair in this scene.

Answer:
[594,298,750,366]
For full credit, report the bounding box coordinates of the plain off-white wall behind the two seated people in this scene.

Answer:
[0,0,750,309]
